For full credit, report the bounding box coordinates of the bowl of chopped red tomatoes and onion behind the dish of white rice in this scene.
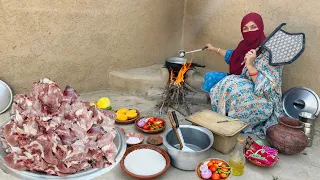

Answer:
[135,117,166,134]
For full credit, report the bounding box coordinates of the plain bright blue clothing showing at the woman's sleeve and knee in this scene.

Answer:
[201,49,233,92]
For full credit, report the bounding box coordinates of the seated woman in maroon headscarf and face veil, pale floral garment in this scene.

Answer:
[205,13,282,139]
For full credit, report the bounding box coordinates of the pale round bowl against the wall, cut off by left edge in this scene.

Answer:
[0,80,13,114]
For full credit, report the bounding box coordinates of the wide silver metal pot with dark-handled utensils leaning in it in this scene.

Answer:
[163,125,214,171]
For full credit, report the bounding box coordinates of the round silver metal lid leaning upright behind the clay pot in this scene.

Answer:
[282,87,320,119]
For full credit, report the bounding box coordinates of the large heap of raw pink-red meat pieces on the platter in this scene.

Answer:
[0,79,117,176]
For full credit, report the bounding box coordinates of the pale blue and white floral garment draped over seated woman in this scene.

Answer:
[210,52,282,139]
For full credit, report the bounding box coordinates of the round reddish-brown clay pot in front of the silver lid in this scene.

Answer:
[266,117,308,154]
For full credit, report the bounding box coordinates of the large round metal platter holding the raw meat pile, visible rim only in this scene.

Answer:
[0,121,127,180]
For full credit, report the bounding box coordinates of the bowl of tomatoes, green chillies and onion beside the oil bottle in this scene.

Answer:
[196,158,231,180]
